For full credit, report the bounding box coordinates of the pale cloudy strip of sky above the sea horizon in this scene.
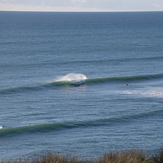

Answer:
[0,0,163,12]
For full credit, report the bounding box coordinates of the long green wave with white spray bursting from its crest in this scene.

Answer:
[0,73,163,94]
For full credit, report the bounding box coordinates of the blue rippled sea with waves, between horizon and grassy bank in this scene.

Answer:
[0,12,163,160]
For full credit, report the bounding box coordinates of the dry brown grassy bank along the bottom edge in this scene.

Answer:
[0,149,163,163]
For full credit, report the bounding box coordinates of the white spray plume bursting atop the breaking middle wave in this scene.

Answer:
[55,73,87,81]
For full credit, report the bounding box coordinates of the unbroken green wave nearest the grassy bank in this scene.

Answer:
[0,110,163,137]
